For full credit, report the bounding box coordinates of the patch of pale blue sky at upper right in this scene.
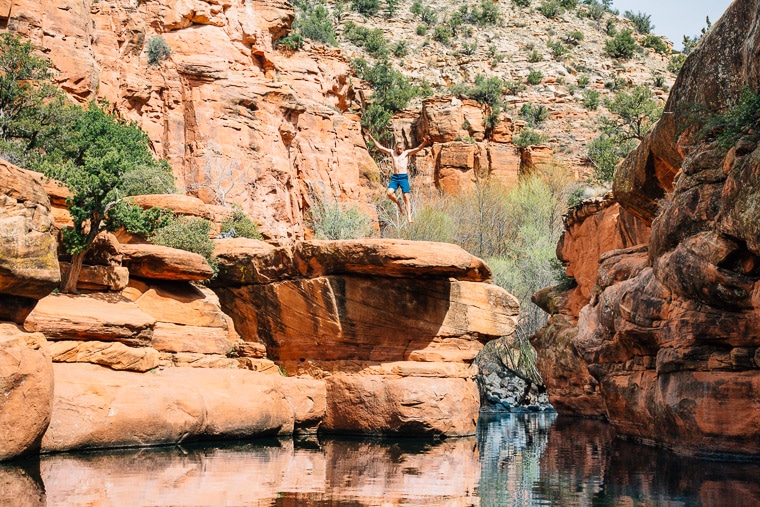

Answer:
[612,0,732,50]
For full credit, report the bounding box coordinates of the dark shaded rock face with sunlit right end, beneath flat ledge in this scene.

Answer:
[220,276,518,373]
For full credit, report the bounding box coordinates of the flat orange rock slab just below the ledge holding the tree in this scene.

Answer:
[24,294,156,346]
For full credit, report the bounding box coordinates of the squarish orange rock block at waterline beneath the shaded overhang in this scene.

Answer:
[321,374,480,436]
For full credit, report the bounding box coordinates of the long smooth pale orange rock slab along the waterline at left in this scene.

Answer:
[42,363,325,452]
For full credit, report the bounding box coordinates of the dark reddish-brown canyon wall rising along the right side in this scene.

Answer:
[533,0,760,455]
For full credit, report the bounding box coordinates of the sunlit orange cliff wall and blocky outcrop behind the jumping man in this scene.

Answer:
[0,0,553,239]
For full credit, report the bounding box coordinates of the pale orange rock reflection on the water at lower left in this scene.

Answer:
[26,438,480,507]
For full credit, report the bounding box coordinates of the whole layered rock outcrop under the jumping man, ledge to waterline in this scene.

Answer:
[215,240,518,435]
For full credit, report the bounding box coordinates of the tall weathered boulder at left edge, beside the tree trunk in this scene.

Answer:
[0,159,61,299]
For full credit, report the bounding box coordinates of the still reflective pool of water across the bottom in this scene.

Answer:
[0,414,760,507]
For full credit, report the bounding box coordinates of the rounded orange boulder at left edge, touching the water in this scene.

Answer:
[0,322,53,461]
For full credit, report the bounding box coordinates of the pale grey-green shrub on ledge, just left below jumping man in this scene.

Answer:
[308,197,372,239]
